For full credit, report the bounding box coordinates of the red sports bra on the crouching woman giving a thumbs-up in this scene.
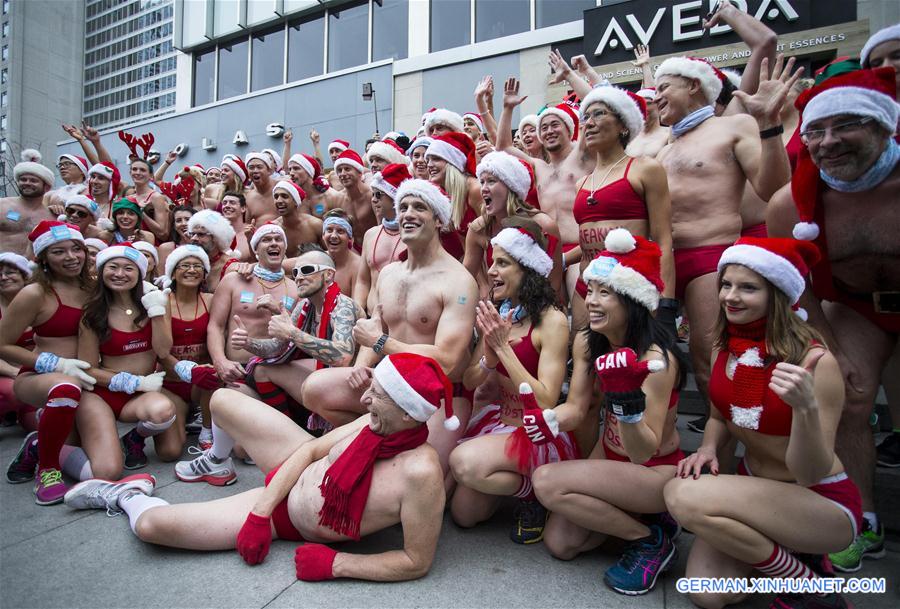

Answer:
[709,351,793,436]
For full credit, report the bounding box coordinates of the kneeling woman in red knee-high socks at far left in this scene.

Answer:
[0,220,95,505]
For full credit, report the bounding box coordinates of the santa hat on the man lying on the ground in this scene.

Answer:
[372,353,459,431]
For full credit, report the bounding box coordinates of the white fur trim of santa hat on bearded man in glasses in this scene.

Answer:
[800,87,900,134]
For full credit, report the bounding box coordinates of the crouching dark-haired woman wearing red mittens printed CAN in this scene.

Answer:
[534,228,685,594]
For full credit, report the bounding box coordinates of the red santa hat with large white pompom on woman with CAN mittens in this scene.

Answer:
[581,228,664,312]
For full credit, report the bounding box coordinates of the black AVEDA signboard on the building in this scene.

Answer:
[584,0,856,65]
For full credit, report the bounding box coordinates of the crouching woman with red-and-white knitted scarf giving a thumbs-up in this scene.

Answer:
[665,237,862,609]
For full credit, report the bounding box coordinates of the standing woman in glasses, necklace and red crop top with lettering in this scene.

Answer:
[572,86,677,329]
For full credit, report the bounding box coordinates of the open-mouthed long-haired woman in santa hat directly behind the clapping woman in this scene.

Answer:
[463,151,562,296]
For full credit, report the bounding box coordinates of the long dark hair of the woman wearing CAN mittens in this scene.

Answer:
[584,292,688,390]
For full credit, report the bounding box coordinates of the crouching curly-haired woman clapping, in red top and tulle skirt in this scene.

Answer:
[450,217,575,543]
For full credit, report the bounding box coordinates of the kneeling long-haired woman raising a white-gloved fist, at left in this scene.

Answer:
[76,243,183,480]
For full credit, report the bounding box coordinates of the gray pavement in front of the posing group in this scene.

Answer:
[0,417,900,609]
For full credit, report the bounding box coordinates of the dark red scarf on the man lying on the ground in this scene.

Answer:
[319,424,428,541]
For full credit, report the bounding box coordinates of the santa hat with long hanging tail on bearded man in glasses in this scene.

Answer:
[791,68,900,241]
